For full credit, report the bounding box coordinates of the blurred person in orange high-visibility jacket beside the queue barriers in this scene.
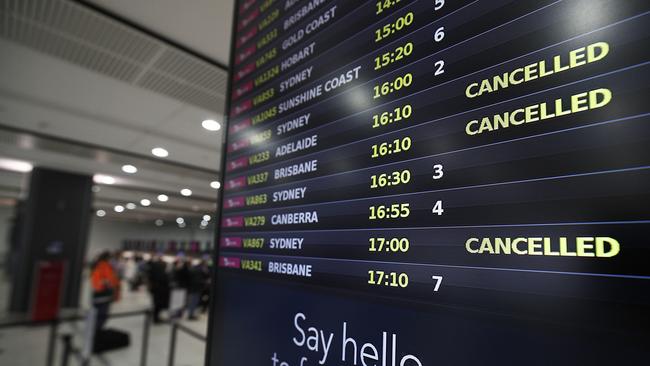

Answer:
[90,252,120,332]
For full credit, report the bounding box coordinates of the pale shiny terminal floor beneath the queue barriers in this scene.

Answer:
[0,277,207,366]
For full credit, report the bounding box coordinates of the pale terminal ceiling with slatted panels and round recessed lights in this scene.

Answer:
[0,0,233,226]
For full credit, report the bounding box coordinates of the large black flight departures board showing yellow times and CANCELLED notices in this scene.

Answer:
[209,0,650,366]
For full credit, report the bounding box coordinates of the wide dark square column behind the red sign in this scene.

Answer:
[10,168,93,312]
